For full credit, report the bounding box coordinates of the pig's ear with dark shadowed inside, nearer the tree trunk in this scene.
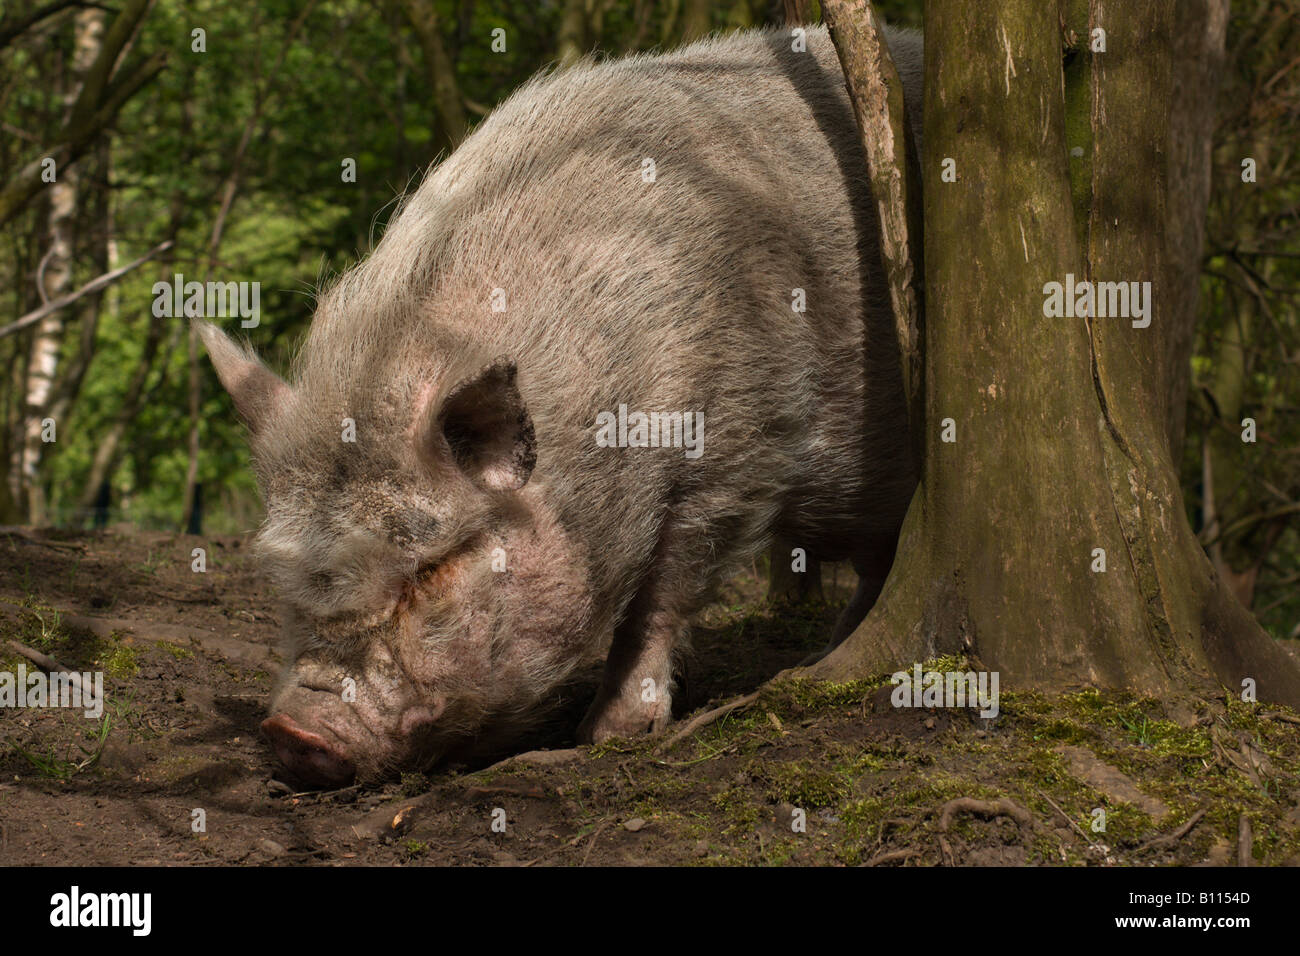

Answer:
[437,360,537,490]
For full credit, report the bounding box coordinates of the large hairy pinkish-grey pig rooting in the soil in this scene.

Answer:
[199,27,922,786]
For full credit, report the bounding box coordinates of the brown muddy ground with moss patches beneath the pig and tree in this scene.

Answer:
[0,528,1300,866]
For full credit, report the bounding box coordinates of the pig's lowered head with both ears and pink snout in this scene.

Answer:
[200,324,592,786]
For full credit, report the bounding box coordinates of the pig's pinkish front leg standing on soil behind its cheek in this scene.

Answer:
[577,594,689,744]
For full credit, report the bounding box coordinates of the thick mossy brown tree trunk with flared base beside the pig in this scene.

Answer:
[810,0,1300,705]
